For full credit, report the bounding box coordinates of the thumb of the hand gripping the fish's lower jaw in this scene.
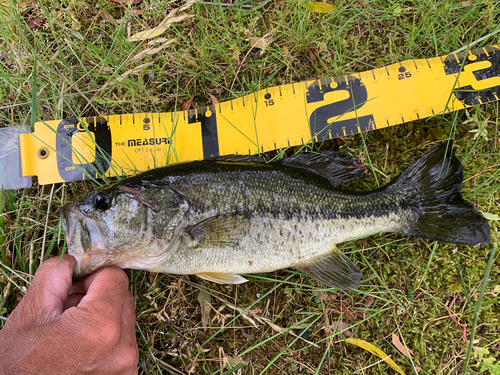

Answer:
[6,254,76,328]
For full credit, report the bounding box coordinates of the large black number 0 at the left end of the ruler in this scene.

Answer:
[56,117,112,181]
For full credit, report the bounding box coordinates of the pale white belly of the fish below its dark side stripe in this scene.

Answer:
[154,214,401,274]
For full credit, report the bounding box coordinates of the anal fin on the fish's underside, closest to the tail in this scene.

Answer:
[293,246,362,289]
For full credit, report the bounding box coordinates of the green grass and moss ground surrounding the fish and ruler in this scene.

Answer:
[0,0,500,374]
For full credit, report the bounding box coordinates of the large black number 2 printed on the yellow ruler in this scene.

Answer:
[306,76,375,141]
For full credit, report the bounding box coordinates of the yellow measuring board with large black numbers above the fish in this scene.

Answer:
[20,46,500,184]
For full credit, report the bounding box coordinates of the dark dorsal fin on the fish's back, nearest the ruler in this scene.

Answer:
[281,151,366,186]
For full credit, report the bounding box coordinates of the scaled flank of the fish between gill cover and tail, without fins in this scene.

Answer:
[154,170,411,274]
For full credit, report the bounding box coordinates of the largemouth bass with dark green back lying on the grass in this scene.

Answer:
[60,141,490,290]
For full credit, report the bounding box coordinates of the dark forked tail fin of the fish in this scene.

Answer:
[388,141,490,245]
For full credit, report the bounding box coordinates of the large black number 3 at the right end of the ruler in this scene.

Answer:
[444,47,500,105]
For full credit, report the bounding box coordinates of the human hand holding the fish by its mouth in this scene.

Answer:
[0,255,139,375]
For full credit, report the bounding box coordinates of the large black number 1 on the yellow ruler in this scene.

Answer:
[188,106,219,159]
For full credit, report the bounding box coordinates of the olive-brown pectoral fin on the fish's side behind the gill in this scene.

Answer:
[186,213,245,248]
